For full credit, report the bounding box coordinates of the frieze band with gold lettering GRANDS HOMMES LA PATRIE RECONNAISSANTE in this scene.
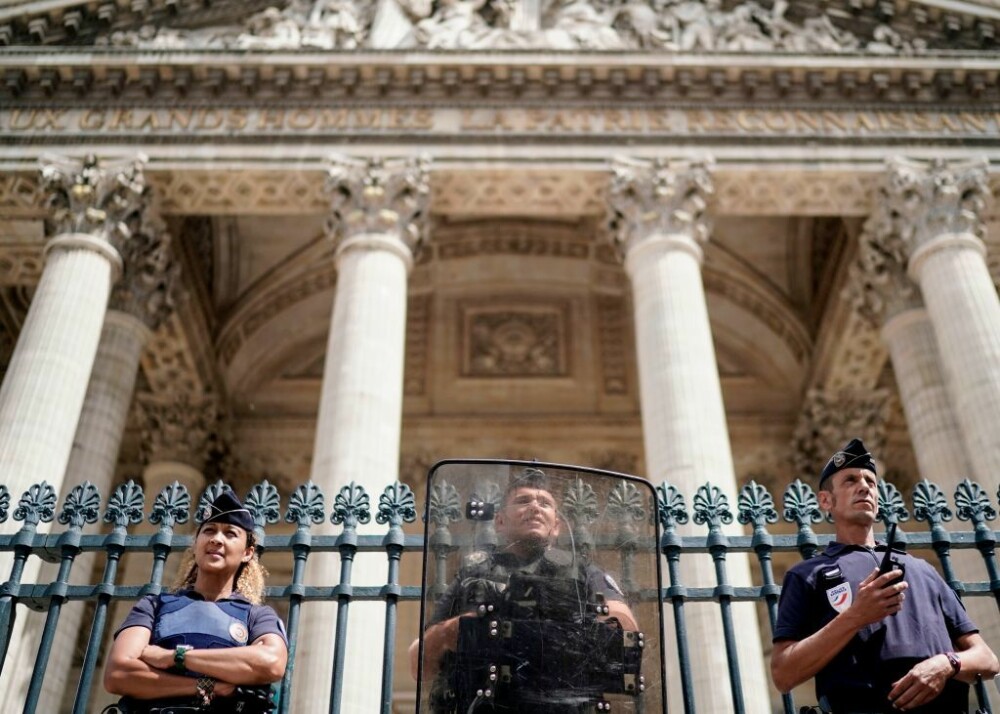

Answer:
[0,106,1000,140]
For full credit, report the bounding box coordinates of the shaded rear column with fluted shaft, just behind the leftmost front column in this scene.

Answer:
[23,217,178,711]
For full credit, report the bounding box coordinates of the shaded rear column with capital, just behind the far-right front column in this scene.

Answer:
[848,209,972,490]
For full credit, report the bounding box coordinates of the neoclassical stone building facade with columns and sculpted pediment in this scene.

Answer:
[0,0,1000,714]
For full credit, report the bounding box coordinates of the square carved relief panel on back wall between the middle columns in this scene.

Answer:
[461,302,569,377]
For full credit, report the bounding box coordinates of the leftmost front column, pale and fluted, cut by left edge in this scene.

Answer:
[0,156,146,711]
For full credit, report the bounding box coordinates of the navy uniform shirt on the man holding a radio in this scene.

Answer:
[774,543,978,712]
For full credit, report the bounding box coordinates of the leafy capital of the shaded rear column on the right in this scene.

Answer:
[843,206,922,329]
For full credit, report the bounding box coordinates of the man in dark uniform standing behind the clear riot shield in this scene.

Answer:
[410,468,638,714]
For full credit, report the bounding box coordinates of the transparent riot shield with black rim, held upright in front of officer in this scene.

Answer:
[417,461,666,714]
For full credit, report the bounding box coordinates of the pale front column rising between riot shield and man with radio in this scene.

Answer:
[610,160,770,714]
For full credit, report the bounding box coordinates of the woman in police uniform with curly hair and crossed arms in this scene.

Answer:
[104,491,288,714]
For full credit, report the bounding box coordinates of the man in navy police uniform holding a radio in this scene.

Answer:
[771,439,998,714]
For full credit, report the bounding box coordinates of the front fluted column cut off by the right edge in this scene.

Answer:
[883,159,1000,485]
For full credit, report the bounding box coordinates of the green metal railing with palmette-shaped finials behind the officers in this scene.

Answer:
[0,472,1000,714]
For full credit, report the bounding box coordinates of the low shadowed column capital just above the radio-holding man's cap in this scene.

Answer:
[792,389,890,479]
